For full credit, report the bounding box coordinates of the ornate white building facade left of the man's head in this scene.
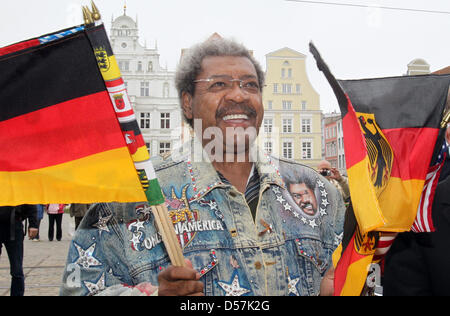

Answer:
[109,12,182,156]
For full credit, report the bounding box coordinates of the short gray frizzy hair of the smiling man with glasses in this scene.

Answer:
[175,37,265,126]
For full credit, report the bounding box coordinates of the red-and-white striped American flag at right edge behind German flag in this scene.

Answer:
[411,141,449,233]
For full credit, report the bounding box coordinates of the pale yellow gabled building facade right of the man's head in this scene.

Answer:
[260,47,322,168]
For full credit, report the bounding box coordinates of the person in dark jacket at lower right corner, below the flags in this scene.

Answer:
[383,172,450,296]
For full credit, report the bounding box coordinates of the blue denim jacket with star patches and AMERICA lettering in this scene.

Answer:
[61,142,345,296]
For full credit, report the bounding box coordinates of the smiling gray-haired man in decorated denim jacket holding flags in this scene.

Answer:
[61,39,344,296]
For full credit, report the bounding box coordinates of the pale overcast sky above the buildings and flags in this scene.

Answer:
[0,0,450,112]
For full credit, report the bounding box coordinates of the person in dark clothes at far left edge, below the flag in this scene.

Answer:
[0,205,38,296]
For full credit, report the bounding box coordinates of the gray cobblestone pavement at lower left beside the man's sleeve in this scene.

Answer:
[0,214,75,296]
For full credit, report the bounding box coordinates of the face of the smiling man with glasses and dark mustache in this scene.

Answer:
[183,56,264,157]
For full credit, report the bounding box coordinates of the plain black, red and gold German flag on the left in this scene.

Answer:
[0,27,147,205]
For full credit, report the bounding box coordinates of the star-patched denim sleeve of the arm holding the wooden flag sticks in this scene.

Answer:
[60,204,157,296]
